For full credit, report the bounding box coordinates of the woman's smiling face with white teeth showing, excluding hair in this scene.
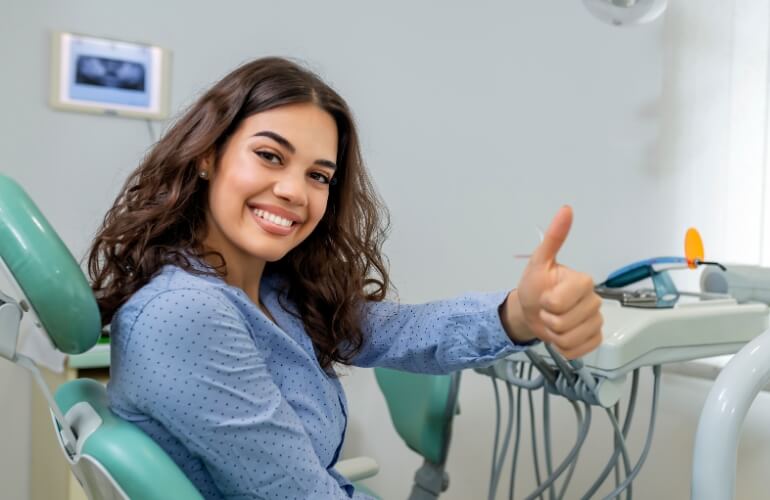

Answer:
[204,104,337,265]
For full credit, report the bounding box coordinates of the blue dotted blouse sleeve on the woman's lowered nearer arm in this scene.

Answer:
[115,290,353,499]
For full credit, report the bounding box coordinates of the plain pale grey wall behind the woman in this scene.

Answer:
[0,0,770,500]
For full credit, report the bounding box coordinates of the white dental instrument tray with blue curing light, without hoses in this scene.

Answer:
[543,254,768,379]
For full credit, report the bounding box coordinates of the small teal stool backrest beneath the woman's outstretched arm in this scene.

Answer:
[374,368,460,465]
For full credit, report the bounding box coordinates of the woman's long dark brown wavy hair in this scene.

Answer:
[88,57,389,372]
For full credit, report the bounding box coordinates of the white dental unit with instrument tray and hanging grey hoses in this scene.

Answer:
[477,230,770,500]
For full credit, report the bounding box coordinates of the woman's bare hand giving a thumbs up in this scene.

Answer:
[500,206,603,359]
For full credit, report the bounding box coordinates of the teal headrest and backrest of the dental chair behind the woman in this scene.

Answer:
[0,175,202,500]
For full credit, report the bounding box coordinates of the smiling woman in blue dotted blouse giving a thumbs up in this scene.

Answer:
[89,58,602,499]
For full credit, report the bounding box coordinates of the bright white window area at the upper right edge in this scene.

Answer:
[655,0,770,265]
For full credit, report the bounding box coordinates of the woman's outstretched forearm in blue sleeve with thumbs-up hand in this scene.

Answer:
[354,207,603,373]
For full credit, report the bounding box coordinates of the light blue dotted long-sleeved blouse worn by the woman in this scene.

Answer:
[107,266,521,499]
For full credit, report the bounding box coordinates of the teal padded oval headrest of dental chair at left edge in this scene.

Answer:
[0,174,101,354]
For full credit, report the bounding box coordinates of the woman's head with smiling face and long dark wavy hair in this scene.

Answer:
[89,58,388,369]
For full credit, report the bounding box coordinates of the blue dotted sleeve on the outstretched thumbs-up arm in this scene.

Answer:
[353,292,531,373]
